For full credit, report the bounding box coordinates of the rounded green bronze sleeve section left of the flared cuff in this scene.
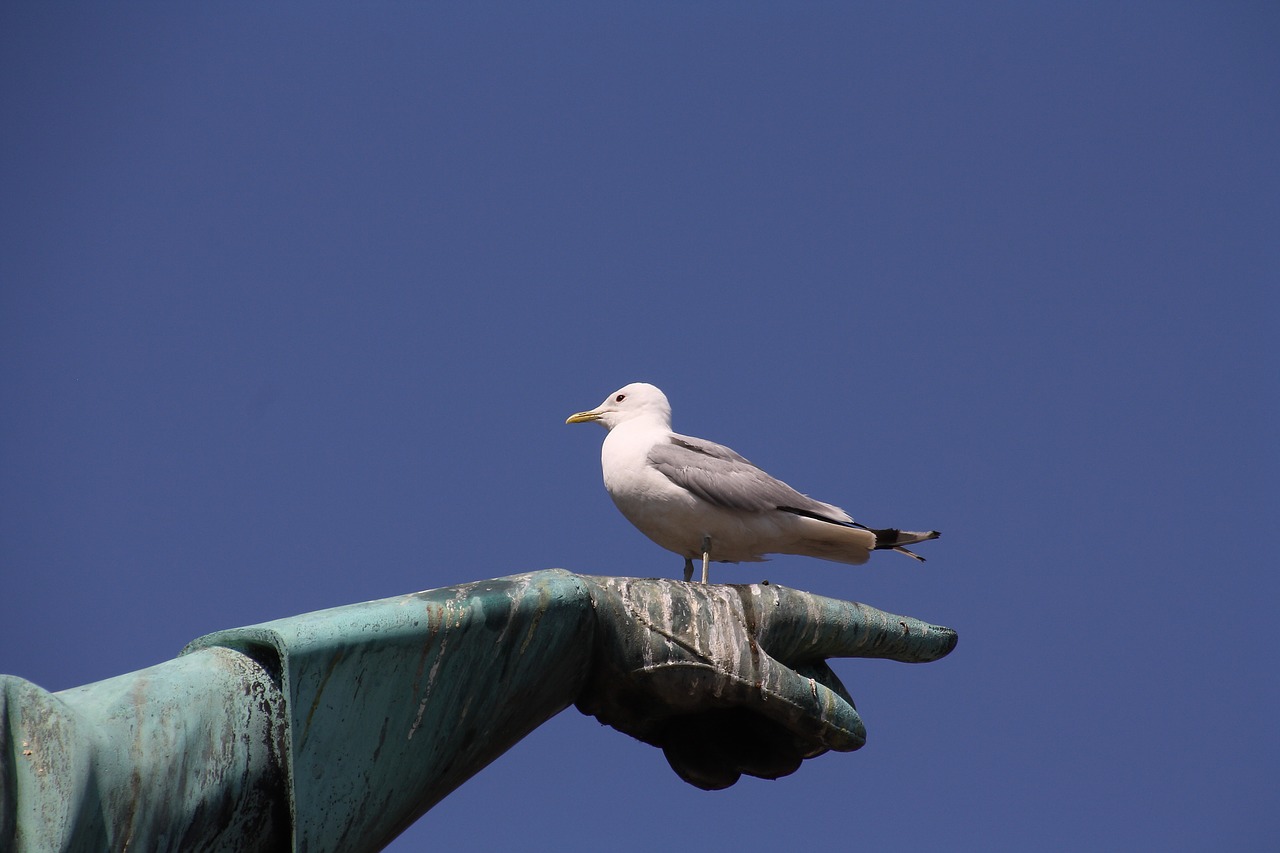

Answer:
[0,648,289,852]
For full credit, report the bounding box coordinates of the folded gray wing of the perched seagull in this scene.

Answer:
[649,435,831,516]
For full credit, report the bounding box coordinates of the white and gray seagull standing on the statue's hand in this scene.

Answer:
[564,382,941,584]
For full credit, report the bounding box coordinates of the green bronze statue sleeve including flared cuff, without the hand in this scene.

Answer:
[0,570,595,850]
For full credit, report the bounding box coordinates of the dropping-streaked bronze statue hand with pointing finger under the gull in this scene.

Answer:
[577,576,956,790]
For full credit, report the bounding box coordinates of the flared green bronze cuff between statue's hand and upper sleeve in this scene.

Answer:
[188,570,594,850]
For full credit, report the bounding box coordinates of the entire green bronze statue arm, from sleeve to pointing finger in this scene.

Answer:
[0,570,955,852]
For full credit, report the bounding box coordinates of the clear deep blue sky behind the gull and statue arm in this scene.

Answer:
[0,1,1280,850]
